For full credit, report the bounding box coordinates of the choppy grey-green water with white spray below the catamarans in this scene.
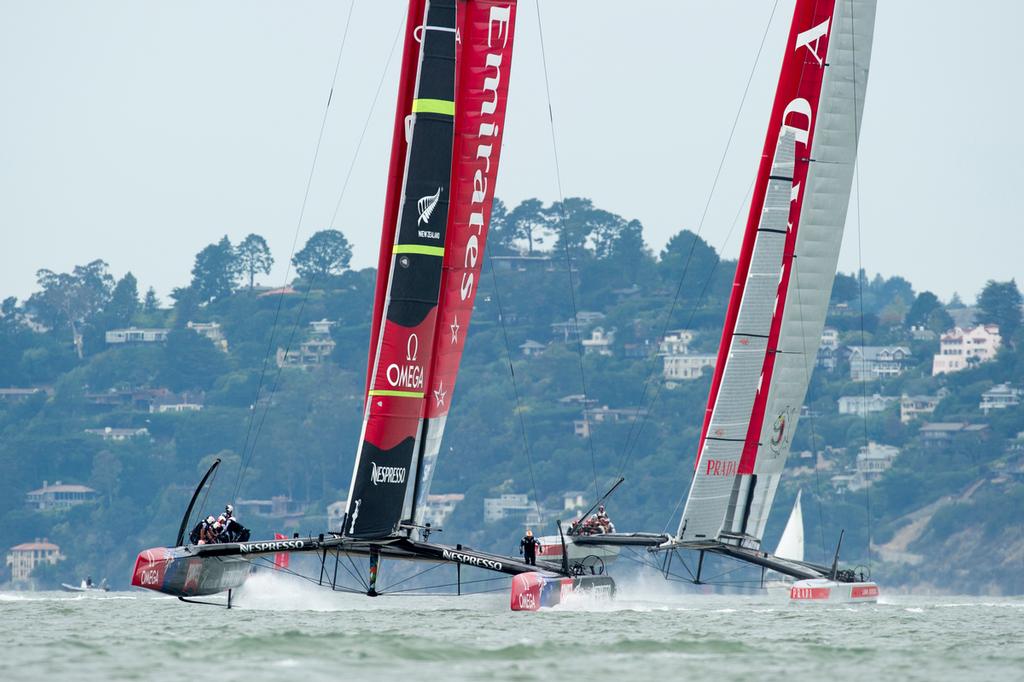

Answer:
[0,574,1024,682]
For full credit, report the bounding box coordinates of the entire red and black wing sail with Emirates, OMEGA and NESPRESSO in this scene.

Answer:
[344,0,515,540]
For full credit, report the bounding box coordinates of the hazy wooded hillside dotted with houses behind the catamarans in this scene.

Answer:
[0,199,1024,593]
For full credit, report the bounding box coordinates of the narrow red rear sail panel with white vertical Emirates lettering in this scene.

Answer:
[417,0,516,522]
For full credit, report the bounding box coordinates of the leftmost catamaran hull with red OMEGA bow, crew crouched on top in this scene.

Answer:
[131,547,251,597]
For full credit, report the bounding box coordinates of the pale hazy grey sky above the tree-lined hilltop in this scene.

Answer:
[0,0,1024,299]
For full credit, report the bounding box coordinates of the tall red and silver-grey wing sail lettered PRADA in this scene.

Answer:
[678,0,876,547]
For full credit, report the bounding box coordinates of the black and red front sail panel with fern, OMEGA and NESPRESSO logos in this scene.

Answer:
[344,0,456,539]
